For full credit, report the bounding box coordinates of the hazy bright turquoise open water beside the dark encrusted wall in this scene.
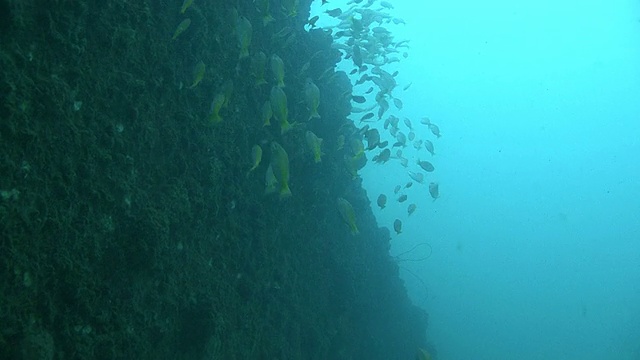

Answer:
[318,0,640,360]
